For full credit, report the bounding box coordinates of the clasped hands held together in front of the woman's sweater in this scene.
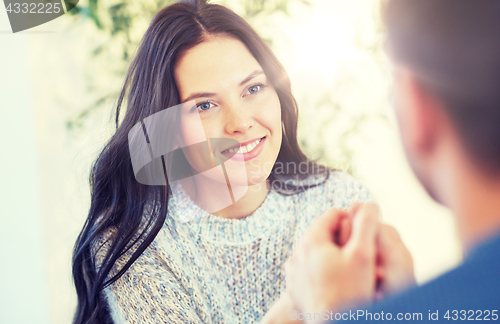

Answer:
[285,203,415,322]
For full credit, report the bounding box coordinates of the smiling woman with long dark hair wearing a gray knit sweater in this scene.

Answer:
[73,1,369,323]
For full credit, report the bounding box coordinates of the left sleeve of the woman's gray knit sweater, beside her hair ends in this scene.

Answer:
[94,224,212,324]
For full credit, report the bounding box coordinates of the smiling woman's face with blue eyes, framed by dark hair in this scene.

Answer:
[175,36,282,185]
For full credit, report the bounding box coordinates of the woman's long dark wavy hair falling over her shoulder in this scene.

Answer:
[73,0,324,324]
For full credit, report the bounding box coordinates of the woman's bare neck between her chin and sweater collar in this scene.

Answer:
[181,176,269,219]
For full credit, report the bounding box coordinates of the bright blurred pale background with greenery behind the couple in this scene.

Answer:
[0,0,462,324]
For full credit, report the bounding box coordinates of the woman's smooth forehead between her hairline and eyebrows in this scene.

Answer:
[175,36,262,96]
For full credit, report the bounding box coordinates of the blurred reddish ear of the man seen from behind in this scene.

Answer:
[396,68,442,156]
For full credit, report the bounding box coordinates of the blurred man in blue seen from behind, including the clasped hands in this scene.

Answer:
[286,0,500,323]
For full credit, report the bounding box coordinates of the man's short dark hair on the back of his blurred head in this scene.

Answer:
[384,0,500,174]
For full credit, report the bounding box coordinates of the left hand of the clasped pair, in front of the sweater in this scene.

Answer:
[285,203,379,313]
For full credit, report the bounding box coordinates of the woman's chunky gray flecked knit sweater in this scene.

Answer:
[94,172,371,324]
